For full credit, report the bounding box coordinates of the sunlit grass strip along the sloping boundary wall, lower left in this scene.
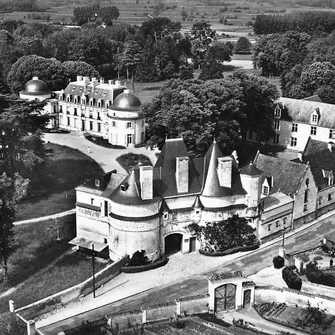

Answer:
[0,251,110,313]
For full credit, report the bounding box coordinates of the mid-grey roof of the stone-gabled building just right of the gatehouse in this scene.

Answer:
[254,152,308,196]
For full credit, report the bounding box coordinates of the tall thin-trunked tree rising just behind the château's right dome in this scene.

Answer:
[114,41,142,91]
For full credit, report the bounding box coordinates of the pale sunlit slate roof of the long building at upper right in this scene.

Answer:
[278,97,335,129]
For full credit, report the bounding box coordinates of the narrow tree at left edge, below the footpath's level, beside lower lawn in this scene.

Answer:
[0,173,29,279]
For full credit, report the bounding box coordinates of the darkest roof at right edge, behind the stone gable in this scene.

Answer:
[296,138,335,190]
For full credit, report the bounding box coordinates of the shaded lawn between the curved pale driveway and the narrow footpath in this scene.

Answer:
[16,143,103,220]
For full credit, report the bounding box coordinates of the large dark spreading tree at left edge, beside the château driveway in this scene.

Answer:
[0,96,49,189]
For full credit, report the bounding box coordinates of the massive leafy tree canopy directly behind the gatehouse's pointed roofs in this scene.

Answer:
[142,72,279,156]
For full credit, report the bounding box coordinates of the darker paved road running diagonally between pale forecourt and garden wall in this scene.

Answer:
[41,214,335,335]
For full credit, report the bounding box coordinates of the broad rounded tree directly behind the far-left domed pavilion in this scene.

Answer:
[7,55,67,93]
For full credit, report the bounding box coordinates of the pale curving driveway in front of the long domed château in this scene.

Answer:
[43,133,159,174]
